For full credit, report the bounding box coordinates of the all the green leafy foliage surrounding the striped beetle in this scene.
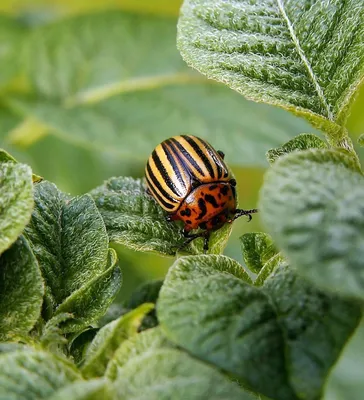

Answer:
[0,0,364,400]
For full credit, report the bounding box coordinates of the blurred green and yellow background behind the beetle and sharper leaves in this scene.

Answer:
[0,0,364,400]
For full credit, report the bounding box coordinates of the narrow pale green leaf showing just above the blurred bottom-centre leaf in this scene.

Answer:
[105,327,175,380]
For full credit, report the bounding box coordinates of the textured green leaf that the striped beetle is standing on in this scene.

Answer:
[91,178,231,255]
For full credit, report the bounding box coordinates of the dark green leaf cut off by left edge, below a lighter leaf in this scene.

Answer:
[0,237,44,341]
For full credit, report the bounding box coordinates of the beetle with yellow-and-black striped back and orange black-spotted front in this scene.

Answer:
[145,135,258,251]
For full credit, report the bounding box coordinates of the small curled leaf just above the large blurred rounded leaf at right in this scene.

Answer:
[267,133,327,164]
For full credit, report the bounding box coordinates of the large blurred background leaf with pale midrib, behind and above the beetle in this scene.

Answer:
[7,11,316,166]
